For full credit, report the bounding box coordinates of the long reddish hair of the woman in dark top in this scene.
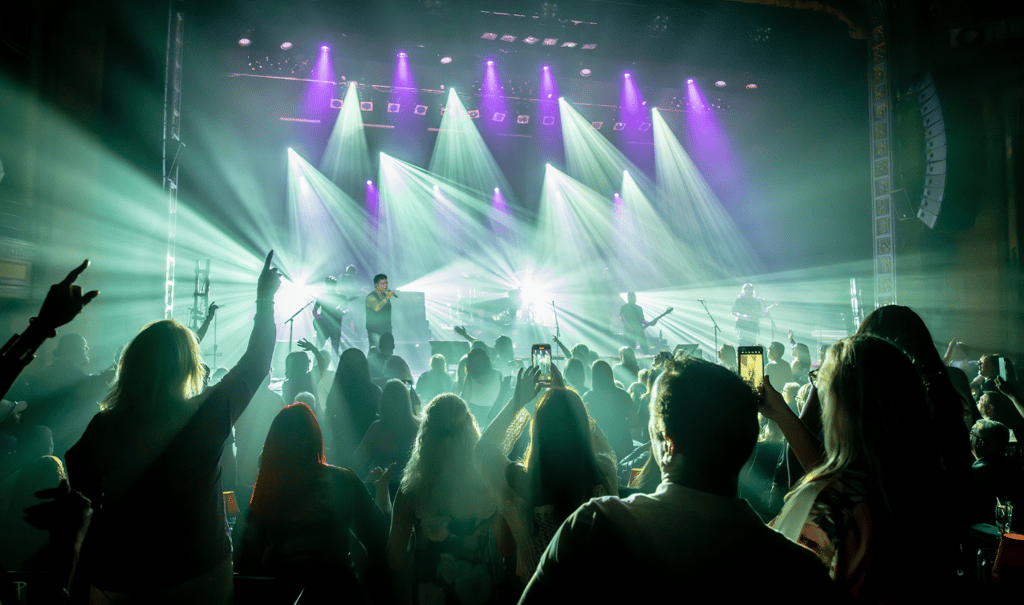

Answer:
[249,403,327,521]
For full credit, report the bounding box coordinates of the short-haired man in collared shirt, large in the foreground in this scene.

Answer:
[520,358,836,603]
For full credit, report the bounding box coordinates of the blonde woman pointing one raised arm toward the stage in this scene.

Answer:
[67,252,281,604]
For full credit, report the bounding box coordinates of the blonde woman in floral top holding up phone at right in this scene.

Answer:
[762,336,956,603]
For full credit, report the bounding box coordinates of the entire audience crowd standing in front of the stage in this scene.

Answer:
[0,257,1024,605]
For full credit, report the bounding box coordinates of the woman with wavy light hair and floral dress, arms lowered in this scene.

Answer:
[387,393,496,605]
